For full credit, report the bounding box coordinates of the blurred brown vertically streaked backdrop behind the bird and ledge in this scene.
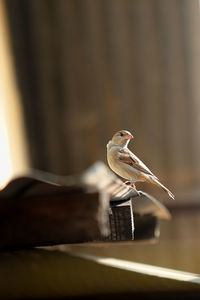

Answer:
[0,0,200,272]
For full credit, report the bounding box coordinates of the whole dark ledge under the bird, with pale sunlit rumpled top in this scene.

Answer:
[0,163,170,249]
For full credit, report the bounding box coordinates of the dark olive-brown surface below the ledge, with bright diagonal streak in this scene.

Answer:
[0,247,200,299]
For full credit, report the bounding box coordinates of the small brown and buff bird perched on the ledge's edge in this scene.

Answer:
[106,130,175,199]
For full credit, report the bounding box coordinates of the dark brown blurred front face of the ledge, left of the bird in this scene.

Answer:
[0,189,103,248]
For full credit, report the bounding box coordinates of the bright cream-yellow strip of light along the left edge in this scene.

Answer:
[0,1,28,189]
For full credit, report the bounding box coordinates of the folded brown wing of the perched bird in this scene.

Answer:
[118,148,157,178]
